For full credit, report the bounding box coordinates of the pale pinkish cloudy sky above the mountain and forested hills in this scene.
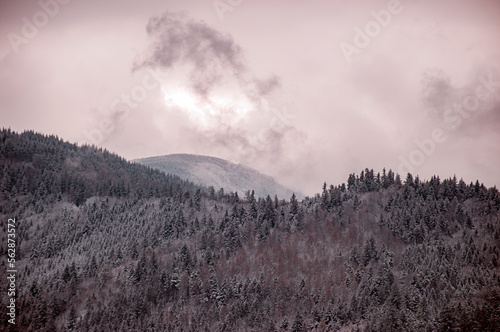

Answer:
[0,0,500,195]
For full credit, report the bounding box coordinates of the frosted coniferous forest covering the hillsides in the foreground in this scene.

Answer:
[0,129,500,332]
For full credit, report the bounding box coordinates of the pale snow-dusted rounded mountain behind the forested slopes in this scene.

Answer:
[134,154,302,199]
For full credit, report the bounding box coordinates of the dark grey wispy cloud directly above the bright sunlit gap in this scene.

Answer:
[133,12,243,96]
